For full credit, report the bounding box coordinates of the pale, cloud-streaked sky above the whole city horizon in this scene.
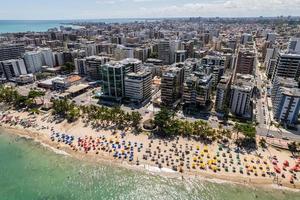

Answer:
[0,0,300,20]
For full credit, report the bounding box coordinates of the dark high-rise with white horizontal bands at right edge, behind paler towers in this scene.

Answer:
[271,52,300,82]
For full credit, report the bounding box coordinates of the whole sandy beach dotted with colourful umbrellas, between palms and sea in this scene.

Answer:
[0,112,300,191]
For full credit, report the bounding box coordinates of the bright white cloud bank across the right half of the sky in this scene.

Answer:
[134,0,300,17]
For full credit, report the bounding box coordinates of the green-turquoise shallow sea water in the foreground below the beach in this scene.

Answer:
[0,129,300,200]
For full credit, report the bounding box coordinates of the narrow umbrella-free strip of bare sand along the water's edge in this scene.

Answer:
[0,125,300,192]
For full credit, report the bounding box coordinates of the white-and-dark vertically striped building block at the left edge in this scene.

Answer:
[0,59,27,80]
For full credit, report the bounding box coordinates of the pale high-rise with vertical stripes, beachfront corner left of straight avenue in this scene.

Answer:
[230,74,254,117]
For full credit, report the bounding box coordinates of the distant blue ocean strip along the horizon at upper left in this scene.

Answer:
[0,18,159,33]
